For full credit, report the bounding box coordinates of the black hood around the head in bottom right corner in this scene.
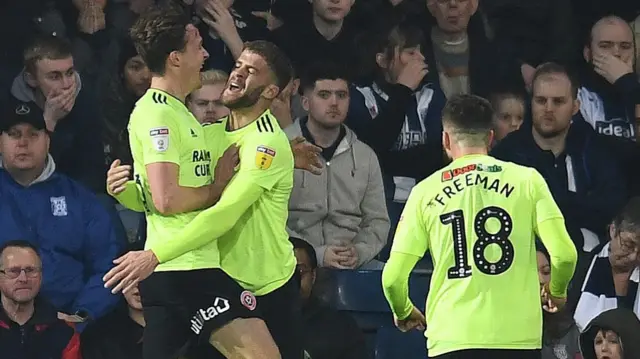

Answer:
[580,308,640,359]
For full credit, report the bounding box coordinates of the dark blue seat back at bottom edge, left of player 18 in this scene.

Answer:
[374,326,427,359]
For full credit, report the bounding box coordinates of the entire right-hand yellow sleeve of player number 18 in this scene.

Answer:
[531,171,578,298]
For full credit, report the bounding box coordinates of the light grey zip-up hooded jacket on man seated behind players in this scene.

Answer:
[285,119,389,267]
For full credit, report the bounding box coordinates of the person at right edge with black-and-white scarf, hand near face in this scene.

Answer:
[573,197,640,334]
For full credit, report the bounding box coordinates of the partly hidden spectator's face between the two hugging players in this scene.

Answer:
[186,70,229,124]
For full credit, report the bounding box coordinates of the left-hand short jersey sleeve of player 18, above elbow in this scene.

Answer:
[391,186,429,257]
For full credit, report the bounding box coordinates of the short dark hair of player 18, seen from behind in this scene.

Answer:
[442,95,493,136]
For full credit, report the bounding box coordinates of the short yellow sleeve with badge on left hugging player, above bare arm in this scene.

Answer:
[129,103,180,165]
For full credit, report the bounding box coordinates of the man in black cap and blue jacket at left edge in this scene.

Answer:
[0,98,124,330]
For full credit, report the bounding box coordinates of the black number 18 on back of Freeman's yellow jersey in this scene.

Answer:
[440,206,513,279]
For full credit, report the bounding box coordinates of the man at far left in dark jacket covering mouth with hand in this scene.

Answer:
[10,33,106,192]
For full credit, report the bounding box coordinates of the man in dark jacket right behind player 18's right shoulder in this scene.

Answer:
[492,63,627,252]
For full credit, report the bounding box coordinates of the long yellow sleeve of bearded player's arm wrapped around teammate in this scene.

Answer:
[150,173,264,263]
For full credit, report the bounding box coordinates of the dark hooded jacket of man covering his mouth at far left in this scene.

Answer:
[11,71,106,192]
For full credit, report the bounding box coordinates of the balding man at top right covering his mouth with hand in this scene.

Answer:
[578,16,640,139]
